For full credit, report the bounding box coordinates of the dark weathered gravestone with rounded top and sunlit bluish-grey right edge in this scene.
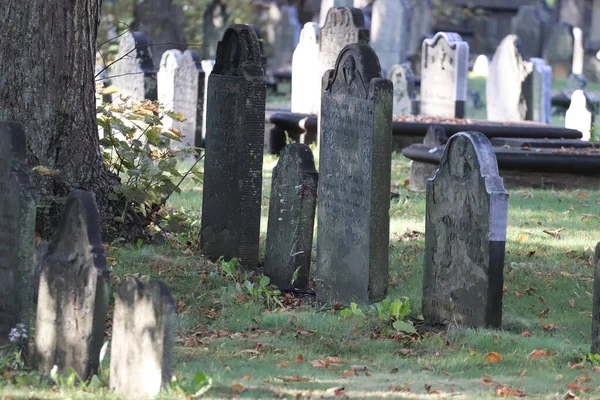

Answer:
[423,132,508,328]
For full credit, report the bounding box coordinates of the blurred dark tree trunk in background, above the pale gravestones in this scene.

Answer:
[132,0,186,65]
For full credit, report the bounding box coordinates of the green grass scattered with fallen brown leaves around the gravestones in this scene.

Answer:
[0,154,600,399]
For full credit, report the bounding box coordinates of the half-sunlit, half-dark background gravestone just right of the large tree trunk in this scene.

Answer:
[109,32,157,101]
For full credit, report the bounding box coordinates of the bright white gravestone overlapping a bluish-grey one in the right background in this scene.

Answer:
[485,35,532,121]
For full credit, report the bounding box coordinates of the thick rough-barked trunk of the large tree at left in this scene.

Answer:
[0,0,119,238]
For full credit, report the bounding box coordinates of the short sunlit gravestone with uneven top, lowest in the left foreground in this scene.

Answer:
[110,276,175,399]
